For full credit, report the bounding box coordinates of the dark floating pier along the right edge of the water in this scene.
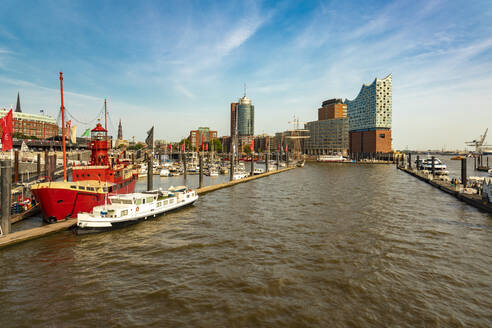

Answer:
[398,166,492,213]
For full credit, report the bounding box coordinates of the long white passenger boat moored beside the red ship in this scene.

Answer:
[77,186,198,233]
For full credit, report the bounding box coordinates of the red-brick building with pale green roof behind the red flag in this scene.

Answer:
[0,93,58,139]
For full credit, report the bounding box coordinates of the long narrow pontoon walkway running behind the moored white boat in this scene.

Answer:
[0,167,295,248]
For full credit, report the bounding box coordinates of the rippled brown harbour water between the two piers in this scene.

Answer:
[0,163,492,327]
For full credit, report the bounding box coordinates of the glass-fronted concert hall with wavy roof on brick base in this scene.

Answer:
[345,74,393,153]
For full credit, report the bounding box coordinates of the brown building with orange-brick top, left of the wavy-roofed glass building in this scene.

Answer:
[304,98,349,156]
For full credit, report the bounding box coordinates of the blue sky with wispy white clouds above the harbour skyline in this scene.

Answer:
[0,0,492,150]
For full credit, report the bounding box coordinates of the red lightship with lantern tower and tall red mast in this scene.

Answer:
[31,73,138,222]
